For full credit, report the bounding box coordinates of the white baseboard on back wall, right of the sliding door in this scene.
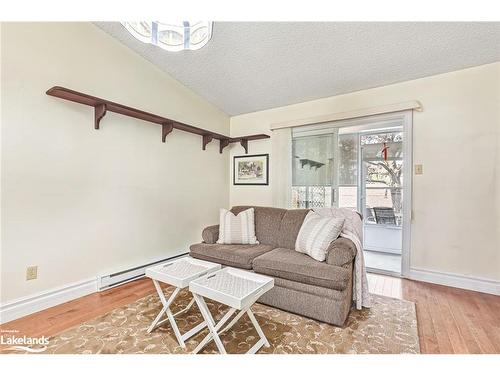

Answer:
[408,268,500,296]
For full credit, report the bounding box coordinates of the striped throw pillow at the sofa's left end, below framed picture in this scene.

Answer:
[217,208,259,245]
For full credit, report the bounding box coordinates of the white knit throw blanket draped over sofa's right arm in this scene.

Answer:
[314,207,372,310]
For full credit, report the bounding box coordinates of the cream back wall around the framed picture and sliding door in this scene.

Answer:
[230,63,500,280]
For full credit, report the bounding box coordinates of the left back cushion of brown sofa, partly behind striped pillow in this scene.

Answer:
[231,206,287,247]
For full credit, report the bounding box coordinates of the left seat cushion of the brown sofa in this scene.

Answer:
[189,243,273,270]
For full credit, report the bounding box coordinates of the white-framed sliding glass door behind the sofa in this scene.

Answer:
[291,113,411,274]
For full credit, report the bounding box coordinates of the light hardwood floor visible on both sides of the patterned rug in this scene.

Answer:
[0,274,500,353]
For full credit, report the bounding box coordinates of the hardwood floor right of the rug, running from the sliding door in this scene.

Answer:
[368,274,500,354]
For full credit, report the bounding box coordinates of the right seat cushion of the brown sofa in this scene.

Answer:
[252,248,351,290]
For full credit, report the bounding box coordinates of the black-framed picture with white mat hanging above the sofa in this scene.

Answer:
[233,154,269,185]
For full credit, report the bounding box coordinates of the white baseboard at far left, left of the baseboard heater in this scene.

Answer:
[0,278,97,323]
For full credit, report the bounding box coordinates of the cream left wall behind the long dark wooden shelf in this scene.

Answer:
[1,23,229,302]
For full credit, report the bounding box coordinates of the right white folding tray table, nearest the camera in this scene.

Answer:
[189,267,274,354]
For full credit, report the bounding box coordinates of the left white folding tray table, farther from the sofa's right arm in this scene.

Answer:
[146,257,221,348]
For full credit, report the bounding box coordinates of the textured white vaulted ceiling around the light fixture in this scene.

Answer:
[95,22,500,115]
